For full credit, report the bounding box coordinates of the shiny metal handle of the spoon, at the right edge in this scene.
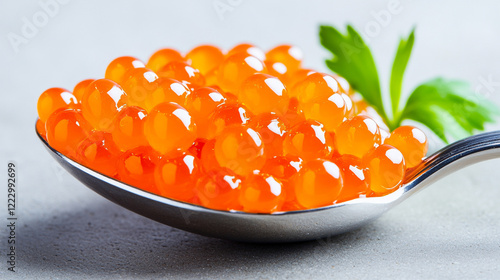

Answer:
[405,131,500,193]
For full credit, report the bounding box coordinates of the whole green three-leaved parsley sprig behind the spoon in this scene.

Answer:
[319,25,500,143]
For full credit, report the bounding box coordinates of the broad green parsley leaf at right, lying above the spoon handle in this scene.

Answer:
[395,78,500,143]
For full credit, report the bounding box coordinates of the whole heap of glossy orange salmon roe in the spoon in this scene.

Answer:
[36,44,427,213]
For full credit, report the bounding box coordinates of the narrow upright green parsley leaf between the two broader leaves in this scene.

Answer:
[390,29,415,123]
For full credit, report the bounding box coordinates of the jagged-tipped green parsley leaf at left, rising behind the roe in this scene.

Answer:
[319,25,388,122]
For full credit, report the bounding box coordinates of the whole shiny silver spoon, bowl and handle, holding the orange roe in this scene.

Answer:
[37,127,500,243]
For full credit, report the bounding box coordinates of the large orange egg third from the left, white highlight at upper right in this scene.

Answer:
[82,79,127,132]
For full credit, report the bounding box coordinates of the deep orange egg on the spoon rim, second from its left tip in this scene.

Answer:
[76,131,120,177]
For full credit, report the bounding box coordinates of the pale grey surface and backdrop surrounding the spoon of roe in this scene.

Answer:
[0,0,500,279]
